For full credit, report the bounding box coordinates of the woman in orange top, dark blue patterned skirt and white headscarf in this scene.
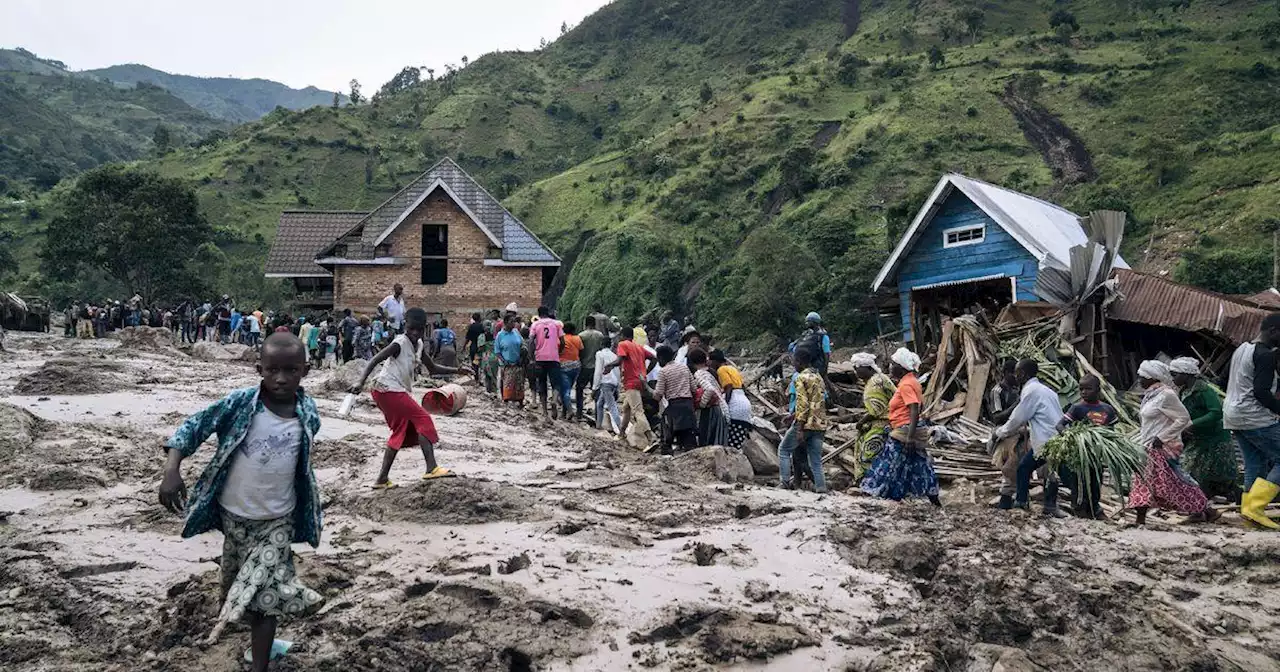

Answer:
[863,348,942,499]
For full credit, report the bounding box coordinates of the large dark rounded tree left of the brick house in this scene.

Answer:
[41,165,212,300]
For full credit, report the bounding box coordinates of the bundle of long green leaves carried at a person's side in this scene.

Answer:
[1039,422,1147,499]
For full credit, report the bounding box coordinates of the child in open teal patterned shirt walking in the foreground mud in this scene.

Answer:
[160,333,324,672]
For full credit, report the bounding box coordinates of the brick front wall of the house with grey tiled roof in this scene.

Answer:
[334,189,543,326]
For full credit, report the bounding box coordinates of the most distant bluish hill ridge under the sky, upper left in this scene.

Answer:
[79,63,347,123]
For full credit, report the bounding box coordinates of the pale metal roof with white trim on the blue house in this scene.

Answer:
[872,173,1129,289]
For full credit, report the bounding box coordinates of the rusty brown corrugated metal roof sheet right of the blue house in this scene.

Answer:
[1107,269,1268,344]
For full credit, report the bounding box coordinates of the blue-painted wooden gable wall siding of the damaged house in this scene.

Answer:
[897,191,1039,340]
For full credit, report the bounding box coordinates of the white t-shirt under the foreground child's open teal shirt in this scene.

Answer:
[218,408,302,521]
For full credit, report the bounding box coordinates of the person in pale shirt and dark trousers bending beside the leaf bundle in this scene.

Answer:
[993,360,1066,518]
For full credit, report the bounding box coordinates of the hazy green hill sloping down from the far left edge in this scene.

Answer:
[0,45,230,196]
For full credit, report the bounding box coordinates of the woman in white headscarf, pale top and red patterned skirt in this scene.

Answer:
[1129,360,1222,525]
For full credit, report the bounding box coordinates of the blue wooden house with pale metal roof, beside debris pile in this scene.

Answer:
[872,173,1128,344]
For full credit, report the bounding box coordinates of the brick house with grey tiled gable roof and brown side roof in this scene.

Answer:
[266,159,561,325]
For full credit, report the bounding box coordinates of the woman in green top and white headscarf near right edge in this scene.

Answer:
[1169,357,1240,502]
